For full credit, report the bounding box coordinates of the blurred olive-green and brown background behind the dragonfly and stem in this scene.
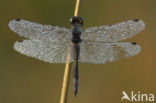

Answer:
[0,0,156,103]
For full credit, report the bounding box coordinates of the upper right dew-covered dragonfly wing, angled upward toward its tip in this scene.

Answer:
[82,19,145,42]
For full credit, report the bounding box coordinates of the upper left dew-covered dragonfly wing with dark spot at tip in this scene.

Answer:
[9,19,72,42]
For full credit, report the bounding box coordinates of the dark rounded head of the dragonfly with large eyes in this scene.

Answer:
[70,16,83,27]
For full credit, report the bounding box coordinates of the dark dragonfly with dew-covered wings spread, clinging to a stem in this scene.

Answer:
[9,16,145,95]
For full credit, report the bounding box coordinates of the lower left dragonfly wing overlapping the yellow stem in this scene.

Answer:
[14,40,74,63]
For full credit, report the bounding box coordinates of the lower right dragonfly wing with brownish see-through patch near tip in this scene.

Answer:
[80,41,141,64]
